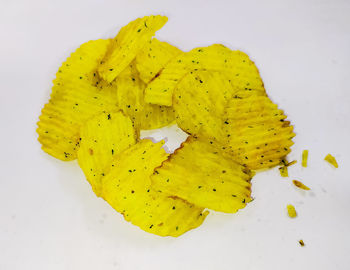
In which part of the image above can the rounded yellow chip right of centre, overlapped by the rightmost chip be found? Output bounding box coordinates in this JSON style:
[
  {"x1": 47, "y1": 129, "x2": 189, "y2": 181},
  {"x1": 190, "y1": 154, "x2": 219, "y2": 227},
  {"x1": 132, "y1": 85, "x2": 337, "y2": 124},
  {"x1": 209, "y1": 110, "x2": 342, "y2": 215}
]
[{"x1": 173, "y1": 70, "x2": 234, "y2": 140}]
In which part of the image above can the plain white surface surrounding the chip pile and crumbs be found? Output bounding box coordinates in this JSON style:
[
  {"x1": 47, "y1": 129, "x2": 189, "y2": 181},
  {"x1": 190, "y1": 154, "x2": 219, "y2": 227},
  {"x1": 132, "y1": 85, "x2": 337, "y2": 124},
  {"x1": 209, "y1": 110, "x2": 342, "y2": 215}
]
[{"x1": 0, "y1": 0, "x2": 350, "y2": 270}]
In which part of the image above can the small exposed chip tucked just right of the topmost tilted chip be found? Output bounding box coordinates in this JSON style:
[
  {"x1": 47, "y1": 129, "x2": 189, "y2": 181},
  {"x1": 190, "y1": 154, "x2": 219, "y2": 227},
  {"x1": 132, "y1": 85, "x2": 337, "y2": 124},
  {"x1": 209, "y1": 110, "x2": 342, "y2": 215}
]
[{"x1": 136, "y1": 38, "x2": 182, "y2": 84}]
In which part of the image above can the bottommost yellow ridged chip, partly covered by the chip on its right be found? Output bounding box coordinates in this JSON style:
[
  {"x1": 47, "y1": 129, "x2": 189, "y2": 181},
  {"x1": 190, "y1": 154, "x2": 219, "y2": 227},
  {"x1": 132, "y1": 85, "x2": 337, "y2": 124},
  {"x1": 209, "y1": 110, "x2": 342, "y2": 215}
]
[{"x1": 102, "y1": 140, "x2": 208, "y2": 236}]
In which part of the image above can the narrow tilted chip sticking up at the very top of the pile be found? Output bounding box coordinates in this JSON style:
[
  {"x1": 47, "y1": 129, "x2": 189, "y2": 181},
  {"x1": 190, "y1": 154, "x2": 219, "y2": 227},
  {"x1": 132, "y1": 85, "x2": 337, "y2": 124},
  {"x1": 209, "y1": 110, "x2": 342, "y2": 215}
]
[{"x1": 98, "y1": 15, "x2": 168, "y2": 82}]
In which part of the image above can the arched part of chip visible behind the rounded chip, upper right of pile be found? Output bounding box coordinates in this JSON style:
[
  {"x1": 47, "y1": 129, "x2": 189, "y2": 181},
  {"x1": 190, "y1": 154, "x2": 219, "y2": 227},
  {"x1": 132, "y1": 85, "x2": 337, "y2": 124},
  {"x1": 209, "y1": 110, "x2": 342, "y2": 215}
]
[{"x1": 145, "y1": 44, "x2": 265, "y2": 106}]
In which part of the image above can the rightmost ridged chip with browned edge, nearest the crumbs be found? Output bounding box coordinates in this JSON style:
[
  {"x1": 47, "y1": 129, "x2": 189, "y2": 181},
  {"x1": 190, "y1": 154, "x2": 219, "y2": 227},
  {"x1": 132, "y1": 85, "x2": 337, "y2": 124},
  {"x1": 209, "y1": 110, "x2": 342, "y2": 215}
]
[{"x1": 222, "y1": 92, "x2": 295, "y2": 170}]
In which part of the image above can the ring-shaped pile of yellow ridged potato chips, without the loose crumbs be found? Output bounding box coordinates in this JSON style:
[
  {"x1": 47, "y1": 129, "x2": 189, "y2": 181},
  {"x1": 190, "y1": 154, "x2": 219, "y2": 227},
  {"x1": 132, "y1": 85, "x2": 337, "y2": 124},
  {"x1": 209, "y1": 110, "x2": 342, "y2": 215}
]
[{"x1": 37, "y1": 16, "x2": 295, "y2": 236}]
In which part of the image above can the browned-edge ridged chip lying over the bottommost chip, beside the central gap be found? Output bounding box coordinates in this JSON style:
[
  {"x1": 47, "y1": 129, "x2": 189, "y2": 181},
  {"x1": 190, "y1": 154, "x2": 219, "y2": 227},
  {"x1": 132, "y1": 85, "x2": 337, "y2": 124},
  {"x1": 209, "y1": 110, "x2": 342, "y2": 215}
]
[{"x1": 151, "y1": 137, "x2": 251, "y2": 213}]
